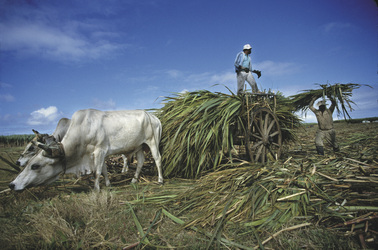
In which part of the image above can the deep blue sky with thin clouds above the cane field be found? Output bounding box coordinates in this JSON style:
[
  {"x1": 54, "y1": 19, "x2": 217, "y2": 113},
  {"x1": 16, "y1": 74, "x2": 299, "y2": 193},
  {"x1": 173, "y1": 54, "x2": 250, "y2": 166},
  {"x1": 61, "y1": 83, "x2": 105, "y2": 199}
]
[{"x1": 0, "y1": 0, "x2": 378, "y2": 135}]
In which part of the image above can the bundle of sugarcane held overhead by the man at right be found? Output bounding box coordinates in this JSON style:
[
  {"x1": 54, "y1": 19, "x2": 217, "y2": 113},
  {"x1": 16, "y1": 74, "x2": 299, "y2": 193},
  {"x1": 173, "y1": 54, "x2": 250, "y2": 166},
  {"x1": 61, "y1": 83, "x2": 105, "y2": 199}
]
[{"x1": 290, "y1": 83, "x2": 371, "y2": 119}]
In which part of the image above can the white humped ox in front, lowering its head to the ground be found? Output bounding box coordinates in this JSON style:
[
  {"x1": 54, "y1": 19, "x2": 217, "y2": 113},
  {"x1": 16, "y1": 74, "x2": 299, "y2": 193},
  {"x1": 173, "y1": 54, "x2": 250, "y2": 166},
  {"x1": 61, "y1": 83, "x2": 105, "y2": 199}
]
[{"x1": 9, "y1": 109, "x2": 163, "y2": 191}]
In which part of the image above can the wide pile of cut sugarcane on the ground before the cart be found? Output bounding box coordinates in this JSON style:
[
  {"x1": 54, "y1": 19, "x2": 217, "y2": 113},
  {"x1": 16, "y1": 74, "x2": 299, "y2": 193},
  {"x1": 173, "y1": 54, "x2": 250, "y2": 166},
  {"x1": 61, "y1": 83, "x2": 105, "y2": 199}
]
[{"x1": 178, "y1": 157, "x2": 378, "y2": 236}]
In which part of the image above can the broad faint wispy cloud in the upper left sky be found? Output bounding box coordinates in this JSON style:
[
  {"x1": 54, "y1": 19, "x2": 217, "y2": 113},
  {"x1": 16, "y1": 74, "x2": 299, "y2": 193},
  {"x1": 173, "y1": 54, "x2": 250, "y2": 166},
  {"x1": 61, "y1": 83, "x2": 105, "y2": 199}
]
[{"x1": 0, "y1": 20, "x2": 127, "y2": 62}]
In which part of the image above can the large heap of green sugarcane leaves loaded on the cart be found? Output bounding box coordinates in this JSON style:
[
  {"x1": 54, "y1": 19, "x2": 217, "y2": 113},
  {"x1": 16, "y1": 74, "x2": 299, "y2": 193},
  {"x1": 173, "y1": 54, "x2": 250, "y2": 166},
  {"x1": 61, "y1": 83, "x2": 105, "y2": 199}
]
[{"x1": 158, "y1": 90, "x2": 300, "y2": 178}]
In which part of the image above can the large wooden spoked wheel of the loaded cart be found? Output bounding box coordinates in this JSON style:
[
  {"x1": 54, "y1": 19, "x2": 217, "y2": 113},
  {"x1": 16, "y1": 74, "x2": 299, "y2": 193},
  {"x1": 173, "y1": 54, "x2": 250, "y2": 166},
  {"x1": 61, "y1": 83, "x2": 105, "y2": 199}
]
[{"x1": 245, "y1": 108, "x2": 282, "y2": 163}]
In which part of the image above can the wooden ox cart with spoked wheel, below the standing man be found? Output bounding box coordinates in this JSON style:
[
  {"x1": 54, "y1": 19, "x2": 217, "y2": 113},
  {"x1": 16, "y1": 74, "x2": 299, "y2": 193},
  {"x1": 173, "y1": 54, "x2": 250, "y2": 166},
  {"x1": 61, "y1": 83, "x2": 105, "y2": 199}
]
[{"x1": 234, "y1": 92, "x2": 282, "y2": 163}]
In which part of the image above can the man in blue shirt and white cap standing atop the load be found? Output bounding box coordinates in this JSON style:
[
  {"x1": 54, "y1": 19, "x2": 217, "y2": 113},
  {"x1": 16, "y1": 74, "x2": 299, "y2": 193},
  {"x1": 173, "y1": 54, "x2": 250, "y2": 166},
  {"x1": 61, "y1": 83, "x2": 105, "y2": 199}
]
[{"x1": 234, "y1": 44, "x2": 261, "y2": 95}]
